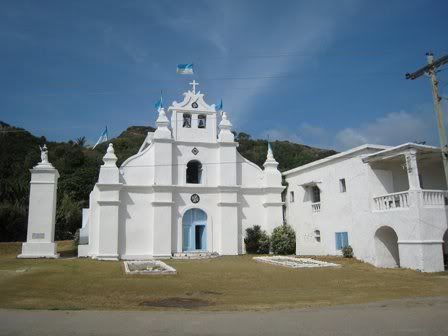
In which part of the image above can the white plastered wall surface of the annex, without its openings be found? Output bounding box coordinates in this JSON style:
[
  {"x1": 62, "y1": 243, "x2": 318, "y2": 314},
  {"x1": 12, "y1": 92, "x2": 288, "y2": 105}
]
[{"x1": 286, "y1": 146, "x2": 448, "y2": 272}]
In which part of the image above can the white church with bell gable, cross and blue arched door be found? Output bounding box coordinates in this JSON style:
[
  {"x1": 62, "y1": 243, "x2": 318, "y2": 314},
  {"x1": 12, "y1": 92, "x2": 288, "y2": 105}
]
[{"x1": 78, "y1": 81, "x2": 284, "y2": 260}]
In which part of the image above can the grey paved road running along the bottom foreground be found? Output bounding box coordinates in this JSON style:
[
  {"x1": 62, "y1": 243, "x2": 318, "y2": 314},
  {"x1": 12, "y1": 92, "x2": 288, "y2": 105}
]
[{"x1": 0, "y1": 298, "x2": 448, "y2": 336}]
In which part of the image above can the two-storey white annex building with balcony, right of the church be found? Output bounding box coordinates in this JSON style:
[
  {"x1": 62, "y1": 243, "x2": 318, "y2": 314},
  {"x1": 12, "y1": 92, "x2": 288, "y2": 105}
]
[{"x1": 283, "y1": 143, "x2": 448, "y2": 272}]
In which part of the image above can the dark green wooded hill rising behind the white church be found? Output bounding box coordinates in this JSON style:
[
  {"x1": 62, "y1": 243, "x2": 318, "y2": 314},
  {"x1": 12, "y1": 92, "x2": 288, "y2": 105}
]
[{"x1": 0, "y1": 121, "x2": 336, "y2": 241}]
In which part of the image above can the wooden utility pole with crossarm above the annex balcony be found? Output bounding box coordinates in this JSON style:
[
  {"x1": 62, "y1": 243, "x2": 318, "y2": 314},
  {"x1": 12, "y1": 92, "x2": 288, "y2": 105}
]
[{"x1": 406, "y1": 53, "x2": 448, "y2": 185}]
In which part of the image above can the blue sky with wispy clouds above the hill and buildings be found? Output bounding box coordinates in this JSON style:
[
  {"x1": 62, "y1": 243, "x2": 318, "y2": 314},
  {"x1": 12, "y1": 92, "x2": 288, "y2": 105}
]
[{"x1": 0, "y1": 0, "x2": 448, "y2": 150}]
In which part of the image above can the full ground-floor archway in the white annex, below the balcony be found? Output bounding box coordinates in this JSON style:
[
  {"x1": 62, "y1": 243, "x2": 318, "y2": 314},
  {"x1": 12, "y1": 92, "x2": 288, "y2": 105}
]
[{"x1": 375, "y1": 226, "x2": 400, "y2": 268}]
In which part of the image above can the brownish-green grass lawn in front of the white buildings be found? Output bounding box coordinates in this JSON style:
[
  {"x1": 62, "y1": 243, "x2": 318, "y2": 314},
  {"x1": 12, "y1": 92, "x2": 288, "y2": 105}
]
[{"x1": 0, "y1": 241, "x2": 448, "y2": 310}]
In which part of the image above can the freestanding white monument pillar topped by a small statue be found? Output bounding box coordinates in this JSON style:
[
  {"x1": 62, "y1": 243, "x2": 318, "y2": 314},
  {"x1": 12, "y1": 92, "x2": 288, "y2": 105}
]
[{"x1": 17, "y1": 145, "x2": 59, "y2": 258}]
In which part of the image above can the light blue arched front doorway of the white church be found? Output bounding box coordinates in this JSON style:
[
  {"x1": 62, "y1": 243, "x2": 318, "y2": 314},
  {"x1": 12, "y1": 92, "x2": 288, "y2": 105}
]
[{"x1": 182, "y1": 209, "x2": 207, "y2": 251}]
